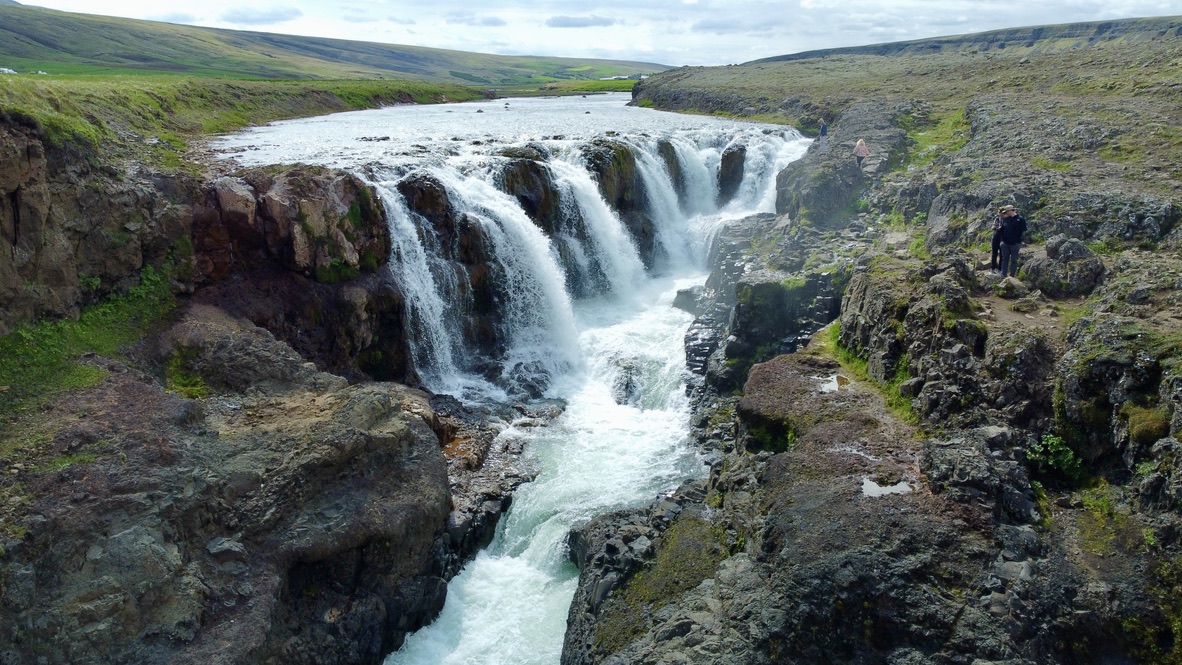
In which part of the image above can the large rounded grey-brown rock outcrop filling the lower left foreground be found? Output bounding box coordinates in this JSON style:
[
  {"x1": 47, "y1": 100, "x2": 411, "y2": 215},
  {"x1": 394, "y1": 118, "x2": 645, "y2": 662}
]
[{"x1": 0, "y1": 307, "x2": 450, "y2": 663}]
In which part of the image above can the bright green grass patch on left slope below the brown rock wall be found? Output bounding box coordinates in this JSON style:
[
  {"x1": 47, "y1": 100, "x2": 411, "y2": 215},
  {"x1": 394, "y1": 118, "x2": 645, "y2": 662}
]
[{"x1": 0, "y1": 267, "x2": 175, "y2": 429}]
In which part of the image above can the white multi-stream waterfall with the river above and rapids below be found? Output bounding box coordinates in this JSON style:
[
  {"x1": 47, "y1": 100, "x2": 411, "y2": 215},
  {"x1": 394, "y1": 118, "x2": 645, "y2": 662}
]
[{"x1": 210, "y1": 96, "x2": 808, "y2": 665}]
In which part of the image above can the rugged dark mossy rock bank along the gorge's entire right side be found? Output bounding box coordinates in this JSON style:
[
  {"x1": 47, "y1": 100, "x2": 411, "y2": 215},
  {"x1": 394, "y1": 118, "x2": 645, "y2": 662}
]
[{"x1": 563, "y1": 20, "x2": 1182, "y2": 665}]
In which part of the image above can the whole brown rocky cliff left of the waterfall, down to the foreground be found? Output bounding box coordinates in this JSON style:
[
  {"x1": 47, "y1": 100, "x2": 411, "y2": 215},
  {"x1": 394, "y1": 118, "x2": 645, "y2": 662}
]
[{"x1": 0, "y1": 116, "x2": 541, "y2": 664}]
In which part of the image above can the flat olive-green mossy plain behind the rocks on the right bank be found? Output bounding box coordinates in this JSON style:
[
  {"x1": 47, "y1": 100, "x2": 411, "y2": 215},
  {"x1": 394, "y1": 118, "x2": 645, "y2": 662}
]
[{"x1": 637, "y1": 19, "x2": 1182, "y2": 198}]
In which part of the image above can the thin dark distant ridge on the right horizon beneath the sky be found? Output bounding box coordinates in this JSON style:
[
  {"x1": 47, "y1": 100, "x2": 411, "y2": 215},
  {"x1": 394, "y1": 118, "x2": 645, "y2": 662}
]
[{"x1": 749, "y1": 17, "x2": 1182, "y2": 64}]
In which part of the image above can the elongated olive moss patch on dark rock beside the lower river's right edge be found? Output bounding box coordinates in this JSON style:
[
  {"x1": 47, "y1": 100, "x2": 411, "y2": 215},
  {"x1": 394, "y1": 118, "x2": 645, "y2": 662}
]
[{"x1": 595, "y1": 515, "x2": 727, "y2": 653}]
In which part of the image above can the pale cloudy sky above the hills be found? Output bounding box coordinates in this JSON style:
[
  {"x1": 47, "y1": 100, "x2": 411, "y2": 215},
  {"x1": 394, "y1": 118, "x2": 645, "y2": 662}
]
[{"x1": 21, "y1": 0, "x2": 1182, "y2": 65}]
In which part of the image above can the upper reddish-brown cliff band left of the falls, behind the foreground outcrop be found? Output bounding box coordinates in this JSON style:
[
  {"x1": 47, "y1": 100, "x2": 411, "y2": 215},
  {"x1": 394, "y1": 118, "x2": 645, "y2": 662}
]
[{"x1": 0, "y1": 117, "x2": 406, "y2": 383}]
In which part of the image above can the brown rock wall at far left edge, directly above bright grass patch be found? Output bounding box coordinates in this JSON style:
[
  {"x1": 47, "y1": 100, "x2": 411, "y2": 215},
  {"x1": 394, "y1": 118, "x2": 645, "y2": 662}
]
[{"x1": 0, "y1": 122, "x2": 191, "y2": 334}]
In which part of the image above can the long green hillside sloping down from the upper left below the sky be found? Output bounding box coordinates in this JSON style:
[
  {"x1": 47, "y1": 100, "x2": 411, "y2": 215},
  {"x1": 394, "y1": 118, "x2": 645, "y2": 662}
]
[{"x1": 0, "y1": 0, "x2": 669, "y2": 86}]
